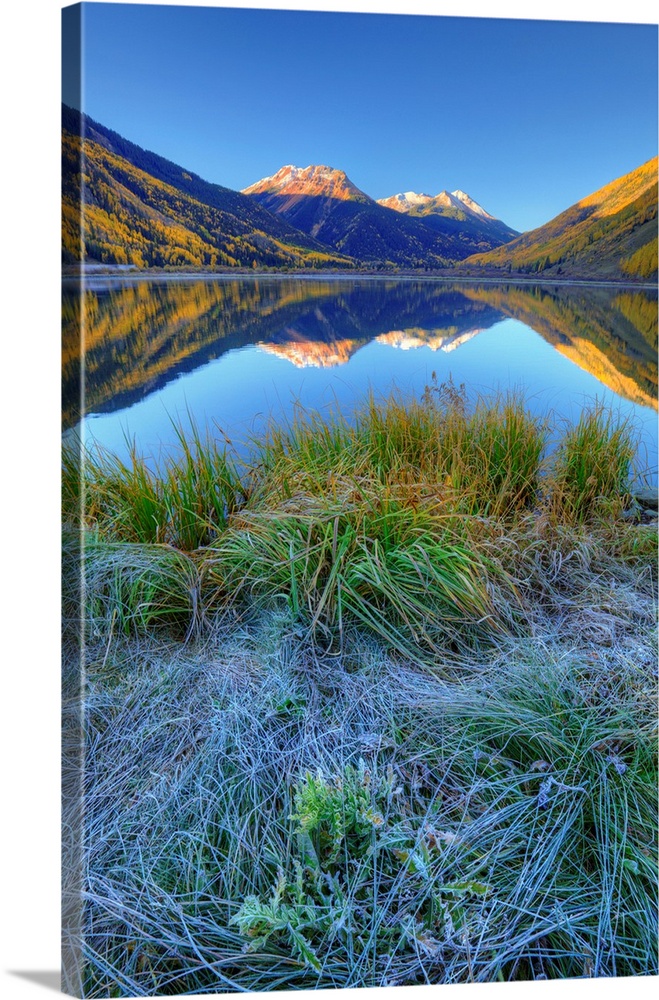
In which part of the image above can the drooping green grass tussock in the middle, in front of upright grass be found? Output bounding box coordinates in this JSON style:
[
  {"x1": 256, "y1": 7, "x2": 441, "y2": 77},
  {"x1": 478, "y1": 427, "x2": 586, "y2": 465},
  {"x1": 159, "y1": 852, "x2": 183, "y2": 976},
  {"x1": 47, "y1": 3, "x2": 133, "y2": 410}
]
[{"x1": 207, "y1": 496, "x2": 513, "y2": 658}]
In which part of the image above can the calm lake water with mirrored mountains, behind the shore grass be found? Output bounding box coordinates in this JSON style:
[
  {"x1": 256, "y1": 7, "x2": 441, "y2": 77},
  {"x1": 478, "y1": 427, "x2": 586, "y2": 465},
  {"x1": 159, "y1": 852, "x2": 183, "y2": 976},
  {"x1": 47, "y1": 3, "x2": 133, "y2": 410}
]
[{"x1": 63, "y1": 277, "x2": 657, "y2": 474}]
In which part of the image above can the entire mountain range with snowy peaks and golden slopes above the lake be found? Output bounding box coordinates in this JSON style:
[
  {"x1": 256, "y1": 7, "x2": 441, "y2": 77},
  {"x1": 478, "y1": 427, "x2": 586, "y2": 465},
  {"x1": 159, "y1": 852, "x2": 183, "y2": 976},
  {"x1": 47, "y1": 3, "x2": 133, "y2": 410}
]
[{"x1": 62, "y1": 106, "x2": 657, "y2": 281}]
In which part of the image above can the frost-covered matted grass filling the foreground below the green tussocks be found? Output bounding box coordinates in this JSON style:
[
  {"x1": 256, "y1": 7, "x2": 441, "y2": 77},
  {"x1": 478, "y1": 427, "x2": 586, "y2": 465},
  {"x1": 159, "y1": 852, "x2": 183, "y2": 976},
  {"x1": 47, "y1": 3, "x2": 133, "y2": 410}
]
[{"x1": 64, "y1": 574, "x2": 657, "y2": 997}]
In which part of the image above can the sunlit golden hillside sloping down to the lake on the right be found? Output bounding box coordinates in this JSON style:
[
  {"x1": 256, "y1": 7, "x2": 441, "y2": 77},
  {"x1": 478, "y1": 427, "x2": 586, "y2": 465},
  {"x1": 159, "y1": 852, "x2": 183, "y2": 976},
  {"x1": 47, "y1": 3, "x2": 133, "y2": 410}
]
[{"x1": 466, "y1": 157, "x2": 657, "y2": 281}]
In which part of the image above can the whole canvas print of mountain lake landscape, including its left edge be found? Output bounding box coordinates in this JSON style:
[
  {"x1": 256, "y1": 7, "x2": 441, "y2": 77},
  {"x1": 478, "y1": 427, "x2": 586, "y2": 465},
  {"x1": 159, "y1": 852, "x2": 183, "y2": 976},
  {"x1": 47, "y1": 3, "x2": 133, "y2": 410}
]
[{"x1": 62, "y1": 3, "x2": 657, "y2": 998}]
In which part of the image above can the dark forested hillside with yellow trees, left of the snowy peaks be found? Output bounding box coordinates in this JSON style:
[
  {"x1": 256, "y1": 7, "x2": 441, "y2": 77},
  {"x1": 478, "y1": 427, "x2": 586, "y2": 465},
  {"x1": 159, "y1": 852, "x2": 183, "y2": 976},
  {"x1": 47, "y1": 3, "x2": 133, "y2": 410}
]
[{"x1": 62, "y1": 108, "x2": 353, "y2": 269}]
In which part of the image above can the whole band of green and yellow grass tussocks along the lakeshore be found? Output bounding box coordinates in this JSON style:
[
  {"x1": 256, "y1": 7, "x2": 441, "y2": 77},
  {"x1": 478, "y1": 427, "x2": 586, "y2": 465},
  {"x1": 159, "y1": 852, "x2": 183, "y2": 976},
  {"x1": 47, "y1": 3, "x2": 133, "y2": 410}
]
[{"x1": 63, "y1": 382, "x2": 652, "y2": 659}]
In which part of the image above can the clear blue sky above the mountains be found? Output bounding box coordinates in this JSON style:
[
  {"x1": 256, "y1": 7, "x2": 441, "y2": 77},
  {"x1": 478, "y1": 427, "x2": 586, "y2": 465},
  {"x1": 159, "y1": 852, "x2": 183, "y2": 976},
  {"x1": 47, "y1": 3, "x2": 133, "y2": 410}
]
[{"x1": 63, "y1": 4, "x2": 657, "y2": 230}]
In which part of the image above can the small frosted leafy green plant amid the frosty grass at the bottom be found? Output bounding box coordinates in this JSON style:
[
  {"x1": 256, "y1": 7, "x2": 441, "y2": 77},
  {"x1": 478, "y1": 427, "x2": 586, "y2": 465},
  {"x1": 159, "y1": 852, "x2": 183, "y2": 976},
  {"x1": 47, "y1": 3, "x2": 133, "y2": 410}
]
[{"x1": 232, "y1": 760, "x2": 490, "y2": 973}]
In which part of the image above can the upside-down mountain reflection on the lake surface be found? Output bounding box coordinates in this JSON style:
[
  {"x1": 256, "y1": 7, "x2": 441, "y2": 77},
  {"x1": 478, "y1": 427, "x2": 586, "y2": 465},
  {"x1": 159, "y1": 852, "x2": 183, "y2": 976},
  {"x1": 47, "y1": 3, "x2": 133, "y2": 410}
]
[{"x1": 63, "y1": 279, "x2": 657, "y2": 426}]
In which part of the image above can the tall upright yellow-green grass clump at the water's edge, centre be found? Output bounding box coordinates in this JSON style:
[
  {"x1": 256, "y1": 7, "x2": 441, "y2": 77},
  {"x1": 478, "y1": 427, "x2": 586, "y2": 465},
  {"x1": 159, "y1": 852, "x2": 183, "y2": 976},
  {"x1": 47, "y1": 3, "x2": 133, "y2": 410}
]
[{"x1": 252, "y1": 382, "x2": 546, "y2": 516}]
